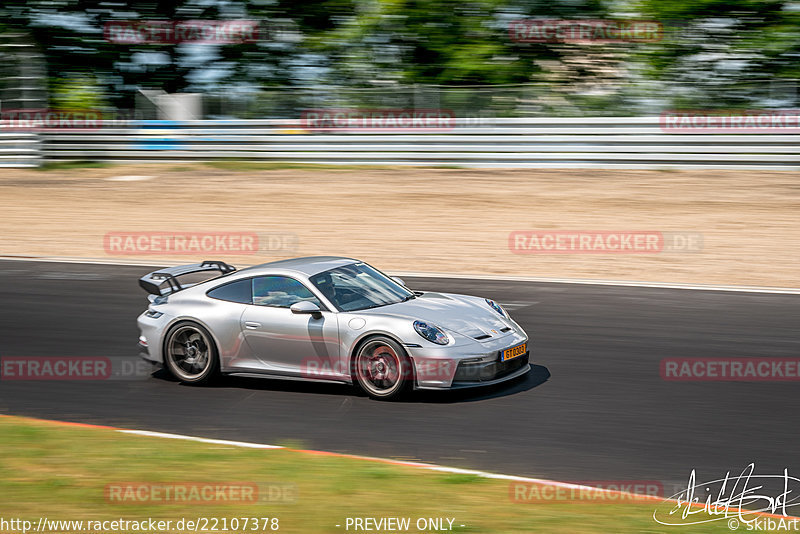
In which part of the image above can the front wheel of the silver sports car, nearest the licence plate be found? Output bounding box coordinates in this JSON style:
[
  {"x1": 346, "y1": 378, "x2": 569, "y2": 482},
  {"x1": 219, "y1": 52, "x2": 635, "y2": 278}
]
[{"x1": 354, "y1": 336, "x2": 413, "y2": 400}]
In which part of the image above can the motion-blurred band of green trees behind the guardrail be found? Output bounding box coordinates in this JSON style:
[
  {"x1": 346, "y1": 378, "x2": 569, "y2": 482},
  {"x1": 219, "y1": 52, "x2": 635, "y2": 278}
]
[{"x1": 0, "y1": 0, "x2": 800, "y2": 113}]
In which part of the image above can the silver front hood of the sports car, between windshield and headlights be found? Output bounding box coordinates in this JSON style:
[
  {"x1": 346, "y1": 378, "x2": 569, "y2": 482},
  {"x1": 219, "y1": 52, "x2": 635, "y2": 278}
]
[{"x1": 361, "y1": 292, "x2": 512, "y2": 339}]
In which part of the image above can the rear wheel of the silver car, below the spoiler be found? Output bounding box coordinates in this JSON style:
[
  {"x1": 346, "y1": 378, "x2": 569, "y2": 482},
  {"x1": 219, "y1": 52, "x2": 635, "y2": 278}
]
[{"x1": 164, "y1": 322, "x2": 219, "y2": 385}]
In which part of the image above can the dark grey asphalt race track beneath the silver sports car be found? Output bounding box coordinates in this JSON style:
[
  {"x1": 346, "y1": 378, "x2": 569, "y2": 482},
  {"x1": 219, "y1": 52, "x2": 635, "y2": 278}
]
[{"x1": 0, "y1": 261, "x2": 800, "y2": 498}]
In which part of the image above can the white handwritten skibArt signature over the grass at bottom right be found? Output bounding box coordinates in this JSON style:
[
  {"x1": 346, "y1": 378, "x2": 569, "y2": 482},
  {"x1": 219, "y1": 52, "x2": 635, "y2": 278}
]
[{"x1": 653, "y1": 463, "x2": 800, "y2": 531}]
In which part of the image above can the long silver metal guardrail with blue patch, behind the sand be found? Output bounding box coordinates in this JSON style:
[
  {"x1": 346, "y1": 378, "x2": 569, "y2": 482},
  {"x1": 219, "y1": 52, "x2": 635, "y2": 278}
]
[{"x1": 20, "y1": 117, "x2": 800, "y2": 170}]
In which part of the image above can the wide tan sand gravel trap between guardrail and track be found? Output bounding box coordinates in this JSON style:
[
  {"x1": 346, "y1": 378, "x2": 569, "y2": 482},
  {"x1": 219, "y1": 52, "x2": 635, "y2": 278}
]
[{"x1": 0, "y1": 164, "x2": 800, "y2": 287}]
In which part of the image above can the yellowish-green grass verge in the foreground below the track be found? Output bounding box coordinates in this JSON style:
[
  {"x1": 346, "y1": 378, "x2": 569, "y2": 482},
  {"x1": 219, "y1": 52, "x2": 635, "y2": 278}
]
[{"x1": 0, "y1": 417, "x2": 730, "y2": 533}]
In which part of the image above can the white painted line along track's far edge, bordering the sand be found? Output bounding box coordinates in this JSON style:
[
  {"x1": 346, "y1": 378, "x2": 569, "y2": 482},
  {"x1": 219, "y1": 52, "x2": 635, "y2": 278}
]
[{"x1": 0, "y1": 256, "x2": 800, "y2": 295}]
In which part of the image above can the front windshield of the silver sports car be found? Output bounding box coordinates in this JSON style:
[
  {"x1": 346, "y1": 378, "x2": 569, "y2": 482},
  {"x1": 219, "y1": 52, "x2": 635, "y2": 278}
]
[{"x1": 309, "y1": 263, "x2": 414, "y2": 311}]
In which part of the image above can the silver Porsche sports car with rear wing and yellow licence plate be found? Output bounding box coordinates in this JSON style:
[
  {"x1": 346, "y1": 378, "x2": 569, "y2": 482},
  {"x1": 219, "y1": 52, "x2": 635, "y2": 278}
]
[{"x1": 138, "y1": 256, "x2": 530, "y2": 399}]
